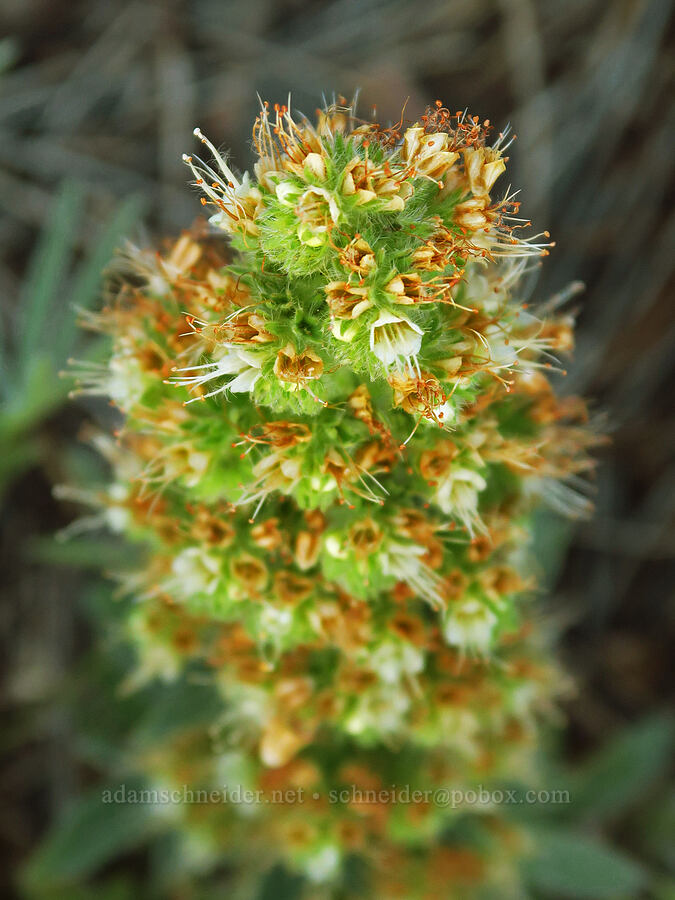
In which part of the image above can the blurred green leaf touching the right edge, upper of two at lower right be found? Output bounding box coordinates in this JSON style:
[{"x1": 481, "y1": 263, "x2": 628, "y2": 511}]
[{"x1": 571, "y1": 715, "x2": 675, "y2": 820}]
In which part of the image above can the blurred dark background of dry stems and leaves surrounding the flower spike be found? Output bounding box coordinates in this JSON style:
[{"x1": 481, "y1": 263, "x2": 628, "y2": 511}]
[{"x1": 0, "y1": 0, "x2": 675, "y2": 900}]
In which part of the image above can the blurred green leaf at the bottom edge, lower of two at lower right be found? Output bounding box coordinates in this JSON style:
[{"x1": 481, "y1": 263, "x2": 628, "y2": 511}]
[{"x1": 523, "y1": 830, "x2": 647, "y2": 900}]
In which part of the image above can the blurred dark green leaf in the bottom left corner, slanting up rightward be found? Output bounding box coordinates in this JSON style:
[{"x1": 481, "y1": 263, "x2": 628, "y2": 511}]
[{"x1": 22, "y1": 778, "x2": 160, "y2": 891}]
